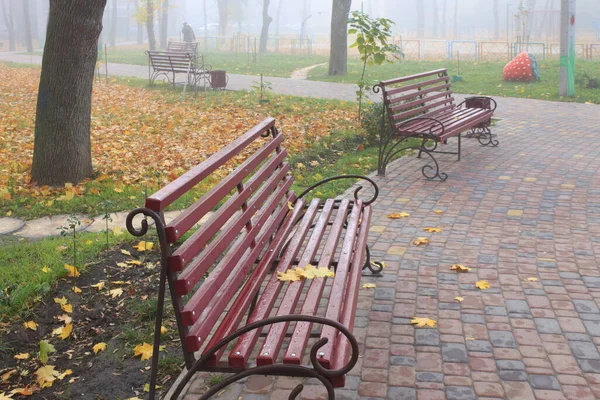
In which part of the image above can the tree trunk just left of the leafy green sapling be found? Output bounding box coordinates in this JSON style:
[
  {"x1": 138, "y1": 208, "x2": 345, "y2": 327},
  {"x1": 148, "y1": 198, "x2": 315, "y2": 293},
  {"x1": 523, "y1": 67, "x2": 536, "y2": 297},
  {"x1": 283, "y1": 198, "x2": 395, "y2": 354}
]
[{"x1": 328, "y1": 0, "x2": 352, "y2": 76}]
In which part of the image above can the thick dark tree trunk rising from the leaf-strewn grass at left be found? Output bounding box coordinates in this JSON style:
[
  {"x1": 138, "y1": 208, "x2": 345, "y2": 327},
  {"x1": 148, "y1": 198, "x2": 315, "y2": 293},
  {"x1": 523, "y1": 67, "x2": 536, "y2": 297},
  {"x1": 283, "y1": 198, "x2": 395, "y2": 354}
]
[{"x1": 31, "y1": 0, "x2": 107, "y2": 185}]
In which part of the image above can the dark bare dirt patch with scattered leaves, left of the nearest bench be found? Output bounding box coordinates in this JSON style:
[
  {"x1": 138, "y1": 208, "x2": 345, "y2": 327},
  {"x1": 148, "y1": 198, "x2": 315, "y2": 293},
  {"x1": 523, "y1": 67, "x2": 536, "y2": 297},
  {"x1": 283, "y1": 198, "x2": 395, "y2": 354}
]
[{"x1": 0, "y1": 245, "x2": 183, "y2": 400}]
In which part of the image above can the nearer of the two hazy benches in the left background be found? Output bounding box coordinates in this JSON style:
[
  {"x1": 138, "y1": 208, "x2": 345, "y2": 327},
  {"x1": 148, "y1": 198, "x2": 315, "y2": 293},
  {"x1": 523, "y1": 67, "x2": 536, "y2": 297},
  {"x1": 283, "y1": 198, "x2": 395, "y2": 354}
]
[{"x1": 146, "y1": 50, "x2": 210, "y2": 90}]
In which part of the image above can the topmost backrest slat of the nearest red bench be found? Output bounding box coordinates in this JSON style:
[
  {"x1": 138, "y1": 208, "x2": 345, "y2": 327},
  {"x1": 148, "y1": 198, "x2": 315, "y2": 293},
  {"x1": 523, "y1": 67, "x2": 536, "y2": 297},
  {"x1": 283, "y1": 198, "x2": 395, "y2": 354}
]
[{"x1": 146, "y1": 117, "x2": 275, "y2": 212}]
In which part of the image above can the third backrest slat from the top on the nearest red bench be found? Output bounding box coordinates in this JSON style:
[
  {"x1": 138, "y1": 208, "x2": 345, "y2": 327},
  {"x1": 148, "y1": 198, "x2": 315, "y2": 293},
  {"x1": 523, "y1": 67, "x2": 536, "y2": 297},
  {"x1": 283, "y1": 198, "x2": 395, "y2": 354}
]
[{"x1": 169, "y1": 152, "x2": 289, "y2": 271}]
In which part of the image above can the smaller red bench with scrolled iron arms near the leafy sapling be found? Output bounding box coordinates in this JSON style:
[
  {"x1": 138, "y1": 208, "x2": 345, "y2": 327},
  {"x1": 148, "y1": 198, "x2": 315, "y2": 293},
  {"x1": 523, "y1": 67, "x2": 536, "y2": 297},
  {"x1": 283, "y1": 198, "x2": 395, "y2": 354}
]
[{"x1": 373, "y1": 69, "x2": 499, "y2": 181}]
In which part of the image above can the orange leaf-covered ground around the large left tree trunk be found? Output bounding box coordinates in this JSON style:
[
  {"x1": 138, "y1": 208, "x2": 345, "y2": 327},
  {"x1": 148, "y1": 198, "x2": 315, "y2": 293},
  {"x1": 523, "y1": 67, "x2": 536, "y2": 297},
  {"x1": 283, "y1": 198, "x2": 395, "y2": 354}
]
[{"x1": 0, "y1": 64, "x2": 356, "y2": 215}]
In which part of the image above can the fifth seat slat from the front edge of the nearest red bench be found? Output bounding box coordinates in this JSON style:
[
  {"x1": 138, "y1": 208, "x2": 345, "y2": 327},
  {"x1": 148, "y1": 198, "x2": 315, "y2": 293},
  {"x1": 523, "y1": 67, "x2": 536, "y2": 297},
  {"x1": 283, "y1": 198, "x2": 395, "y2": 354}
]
[{"x1": 229, "y1": 199, "x2": 319, "y2": 368}]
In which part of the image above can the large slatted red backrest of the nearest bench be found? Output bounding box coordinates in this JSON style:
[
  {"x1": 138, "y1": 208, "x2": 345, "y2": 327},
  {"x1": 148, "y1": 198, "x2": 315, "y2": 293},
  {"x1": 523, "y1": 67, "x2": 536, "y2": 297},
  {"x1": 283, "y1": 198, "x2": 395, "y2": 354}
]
[{"x1": 146, "y1": 118, "x2": 304, "y2": 365}]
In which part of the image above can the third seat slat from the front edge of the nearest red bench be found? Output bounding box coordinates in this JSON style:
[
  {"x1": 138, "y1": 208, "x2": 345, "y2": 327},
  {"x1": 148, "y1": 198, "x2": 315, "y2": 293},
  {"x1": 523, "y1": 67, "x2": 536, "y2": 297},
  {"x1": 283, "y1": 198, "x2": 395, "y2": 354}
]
[{"x1": 283, "y1": 199, "x2": 350, "y2": 364}]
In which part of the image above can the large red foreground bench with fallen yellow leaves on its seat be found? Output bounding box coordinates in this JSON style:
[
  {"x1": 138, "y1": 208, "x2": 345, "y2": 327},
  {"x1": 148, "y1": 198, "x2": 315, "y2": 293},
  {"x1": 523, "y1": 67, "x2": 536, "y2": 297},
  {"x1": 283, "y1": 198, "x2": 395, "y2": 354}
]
[{"x1": 126, "y1": 118, "x2": 382, "y2": 398}]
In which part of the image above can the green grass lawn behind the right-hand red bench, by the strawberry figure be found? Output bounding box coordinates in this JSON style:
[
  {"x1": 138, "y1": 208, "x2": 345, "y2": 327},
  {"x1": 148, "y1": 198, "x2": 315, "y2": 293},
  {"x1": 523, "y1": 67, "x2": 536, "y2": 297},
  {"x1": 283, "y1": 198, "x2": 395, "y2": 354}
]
[{"x1": 309, "y1": 58, "x2": 600, "y2": 103}]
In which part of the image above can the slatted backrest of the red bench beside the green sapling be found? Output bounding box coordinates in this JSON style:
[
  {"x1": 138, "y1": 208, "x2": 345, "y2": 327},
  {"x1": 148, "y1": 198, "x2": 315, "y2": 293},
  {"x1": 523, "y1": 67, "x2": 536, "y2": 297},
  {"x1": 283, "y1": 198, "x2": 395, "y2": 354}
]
[{"x1": 379, "y1": 69, "x2": 455, "y2": 126}]
